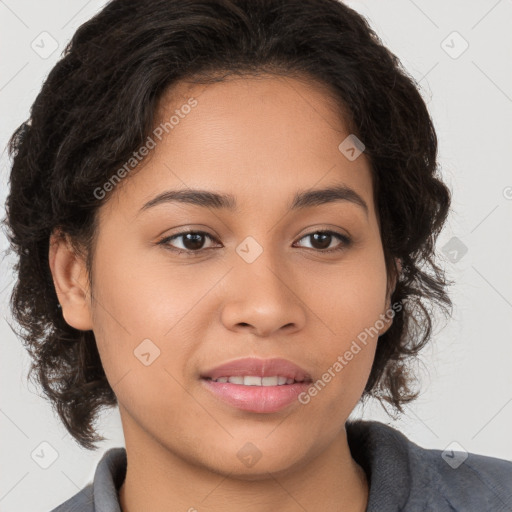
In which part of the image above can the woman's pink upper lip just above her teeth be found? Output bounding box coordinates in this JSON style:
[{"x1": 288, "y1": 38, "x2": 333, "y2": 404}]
[{"x1": 201, "y1": 357, "x2": 311, "y2": 382}]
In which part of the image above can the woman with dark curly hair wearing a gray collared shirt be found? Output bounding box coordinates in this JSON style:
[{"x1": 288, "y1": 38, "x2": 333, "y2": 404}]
[{"x1": 7, "y1": 0, "x2": 512, "y2": 512}]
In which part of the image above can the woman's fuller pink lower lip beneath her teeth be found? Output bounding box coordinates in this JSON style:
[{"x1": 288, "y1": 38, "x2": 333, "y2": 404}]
[{"x1": 201, "y1": 379, "x2": 310, "y2": 413}]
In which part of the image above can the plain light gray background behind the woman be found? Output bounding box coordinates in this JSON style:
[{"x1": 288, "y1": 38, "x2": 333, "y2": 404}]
[{"x1": 0, "y1": 0, "x2": 512, "y2": 512}]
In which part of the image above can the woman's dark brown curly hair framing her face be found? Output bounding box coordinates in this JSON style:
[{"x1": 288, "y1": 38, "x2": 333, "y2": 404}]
[{"x1": 5, "y1": 0, "x2": 452, "y2": 449}]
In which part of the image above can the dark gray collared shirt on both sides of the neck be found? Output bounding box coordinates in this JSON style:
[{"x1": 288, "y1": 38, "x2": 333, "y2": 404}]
[{"x1": 51, "y1": 421, "x2": 512, "y2": 512}]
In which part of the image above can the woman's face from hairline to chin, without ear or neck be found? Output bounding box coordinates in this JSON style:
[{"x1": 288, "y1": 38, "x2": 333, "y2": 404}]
[{"x1": 83, "y1": 76, "x2": 389, "y2": 478}]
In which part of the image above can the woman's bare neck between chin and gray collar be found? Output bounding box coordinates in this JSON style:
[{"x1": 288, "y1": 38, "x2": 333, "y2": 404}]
[{"x1": 119, "y1": 418, "x2": 368, "y2": 512}]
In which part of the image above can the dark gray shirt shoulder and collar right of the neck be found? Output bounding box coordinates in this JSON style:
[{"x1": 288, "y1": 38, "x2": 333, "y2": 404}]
[{"x1": 347, "y1": 421, "x2": 512, "y2": 512}]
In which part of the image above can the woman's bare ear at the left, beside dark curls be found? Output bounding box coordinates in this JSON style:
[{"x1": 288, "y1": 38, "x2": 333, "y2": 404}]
[{"x1": 48, "y1": 231, "x2": 92, "y2": 331}]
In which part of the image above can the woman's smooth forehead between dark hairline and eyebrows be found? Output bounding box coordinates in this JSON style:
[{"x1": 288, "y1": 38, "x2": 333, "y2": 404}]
[{"x1": 102, "y1": 75, "x2": 373, "y2": 220}]
